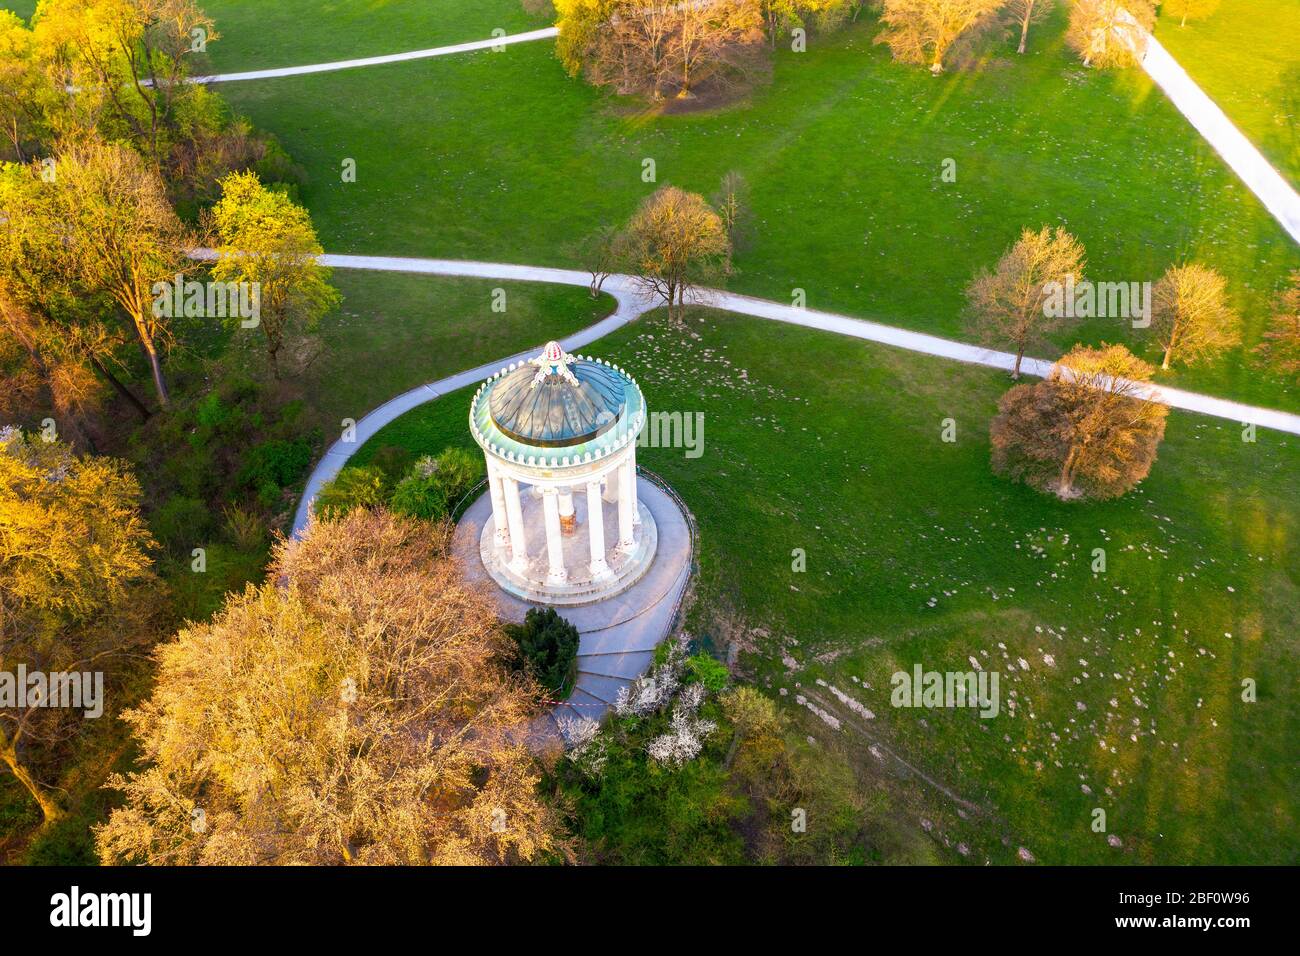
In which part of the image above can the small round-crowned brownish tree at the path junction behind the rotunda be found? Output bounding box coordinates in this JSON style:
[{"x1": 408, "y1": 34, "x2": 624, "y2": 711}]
[{"x1": 625, "y1": 186, "x2": 731, "y2": 320}]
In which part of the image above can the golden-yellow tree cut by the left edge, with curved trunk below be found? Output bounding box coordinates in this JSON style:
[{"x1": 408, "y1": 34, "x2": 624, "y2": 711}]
[{"x1": 0, "y1": 428, "x2": 157, "y2": 823}]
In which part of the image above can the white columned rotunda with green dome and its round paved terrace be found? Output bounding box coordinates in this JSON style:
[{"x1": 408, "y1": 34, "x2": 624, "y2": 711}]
[{"x1": 452, "y1": 342, "x2": 693, "y2": 735}]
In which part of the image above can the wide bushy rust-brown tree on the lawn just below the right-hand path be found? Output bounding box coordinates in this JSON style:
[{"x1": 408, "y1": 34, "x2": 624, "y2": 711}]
[{"x1": 989, "y1": 345, "x2": 1169, "y2": 501}]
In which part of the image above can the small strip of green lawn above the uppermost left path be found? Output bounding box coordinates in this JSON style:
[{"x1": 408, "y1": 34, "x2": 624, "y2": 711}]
[{"x1": 202, "y1": 0, "x2": 549, "y2": 73}]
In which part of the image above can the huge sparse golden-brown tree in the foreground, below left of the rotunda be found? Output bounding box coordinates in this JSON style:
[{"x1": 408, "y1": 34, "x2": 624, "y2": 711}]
[{"x1": 95, "y1": 512, "x2": 569, "y2": 865}]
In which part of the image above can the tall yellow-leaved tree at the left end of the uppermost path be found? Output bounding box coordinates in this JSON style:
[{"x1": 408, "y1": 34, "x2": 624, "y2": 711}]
[{"x1": 33, "y1": 0, "x2": 218, "y2": 172}]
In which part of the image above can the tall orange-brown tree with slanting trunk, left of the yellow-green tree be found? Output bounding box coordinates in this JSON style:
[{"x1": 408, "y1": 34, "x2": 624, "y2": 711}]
[{"x1": 56, "y1": 142, "x2": 195, "y2": 407}]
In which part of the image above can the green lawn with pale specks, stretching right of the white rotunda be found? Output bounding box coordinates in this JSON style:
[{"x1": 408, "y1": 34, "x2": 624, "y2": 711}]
[{"x1": 361, "y1": 313, "x2": 1300, "y2": 864}]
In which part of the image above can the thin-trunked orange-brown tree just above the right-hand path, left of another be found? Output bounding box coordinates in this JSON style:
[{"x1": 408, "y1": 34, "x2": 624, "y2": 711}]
[{"x1": 966, "y1": 226, "x2": 1084, "y2": 378}]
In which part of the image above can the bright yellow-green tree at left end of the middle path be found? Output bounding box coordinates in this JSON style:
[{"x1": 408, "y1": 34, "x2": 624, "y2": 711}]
[{"x1": 212, "y1": 173, "x2": 341, "y2": 378}]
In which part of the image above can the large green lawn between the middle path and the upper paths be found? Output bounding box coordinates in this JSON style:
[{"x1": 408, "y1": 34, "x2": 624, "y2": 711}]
[{"x1": 224, "y1": 10, "x2": 1300, "y2": 408}]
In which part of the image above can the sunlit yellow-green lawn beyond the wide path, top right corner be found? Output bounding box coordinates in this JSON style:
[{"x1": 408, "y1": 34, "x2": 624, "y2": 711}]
[{"x1": 1156, "y1": 0, "x2": 1300, "y2": 186}]
